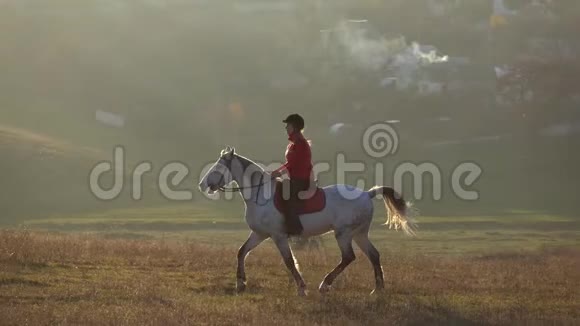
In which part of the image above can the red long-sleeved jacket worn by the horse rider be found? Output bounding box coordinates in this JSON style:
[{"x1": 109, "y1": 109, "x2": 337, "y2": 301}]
[{"x1": 275, "y1": 132, "x2": 312, "y2": 180}]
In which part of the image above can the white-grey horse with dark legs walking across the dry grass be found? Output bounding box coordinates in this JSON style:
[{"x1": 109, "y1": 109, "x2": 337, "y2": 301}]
[{"x1": 199, "y1": 146, "x2": 416, "y2": 295}]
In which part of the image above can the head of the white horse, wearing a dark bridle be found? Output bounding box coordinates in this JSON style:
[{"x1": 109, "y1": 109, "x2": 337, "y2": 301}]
[{"x1": 199, "y1": 146, "x2": 236, "y2": 194}]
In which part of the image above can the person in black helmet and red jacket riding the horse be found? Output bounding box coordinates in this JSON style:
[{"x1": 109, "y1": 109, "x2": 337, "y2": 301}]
[{"x1": 272, "y1": 113, "x2": 312, "y2": 235}]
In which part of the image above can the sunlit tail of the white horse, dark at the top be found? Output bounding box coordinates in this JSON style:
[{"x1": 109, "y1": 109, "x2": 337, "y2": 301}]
[{"x1": 367, "y1": 186, "x2": 417, "y2": 236}]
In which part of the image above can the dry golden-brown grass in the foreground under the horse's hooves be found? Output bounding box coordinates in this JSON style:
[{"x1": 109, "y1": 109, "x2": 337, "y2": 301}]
[{"x1": 0, "y1": 230, "x2": 580, "y2": 325}]
